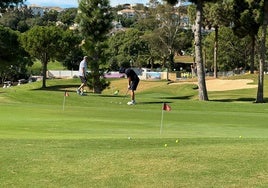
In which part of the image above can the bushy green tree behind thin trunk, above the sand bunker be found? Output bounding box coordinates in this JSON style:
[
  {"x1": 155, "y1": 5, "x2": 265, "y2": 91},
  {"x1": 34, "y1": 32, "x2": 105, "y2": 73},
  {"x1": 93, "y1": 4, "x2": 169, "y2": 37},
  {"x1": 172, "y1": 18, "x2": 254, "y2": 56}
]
[{"x1": 203, "y1": 27, "x2": 250, "y2": 73}]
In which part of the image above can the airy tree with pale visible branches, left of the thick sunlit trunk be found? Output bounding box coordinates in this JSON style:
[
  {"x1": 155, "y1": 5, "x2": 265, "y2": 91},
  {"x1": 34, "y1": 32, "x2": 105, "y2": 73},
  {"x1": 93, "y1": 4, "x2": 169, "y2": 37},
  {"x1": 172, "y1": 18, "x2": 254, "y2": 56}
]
[{"x1": 135, "y1": 0, "x2": 192, "y2": 70}]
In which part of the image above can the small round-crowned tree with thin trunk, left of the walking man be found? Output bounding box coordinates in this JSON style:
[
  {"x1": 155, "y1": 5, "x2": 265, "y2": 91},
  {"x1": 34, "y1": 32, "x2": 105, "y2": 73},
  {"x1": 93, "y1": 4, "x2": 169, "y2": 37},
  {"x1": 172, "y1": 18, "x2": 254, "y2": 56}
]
[{"x1": 20, "y1": 26, "x2": 77, "y2": 88}]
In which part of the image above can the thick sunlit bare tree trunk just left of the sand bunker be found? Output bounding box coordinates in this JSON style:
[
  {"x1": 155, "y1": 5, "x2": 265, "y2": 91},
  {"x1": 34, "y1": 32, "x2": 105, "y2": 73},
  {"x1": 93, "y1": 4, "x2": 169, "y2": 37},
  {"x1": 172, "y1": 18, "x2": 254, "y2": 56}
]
[{"x1": 194, "y1": 0, "x2": 208, "y2": 101}]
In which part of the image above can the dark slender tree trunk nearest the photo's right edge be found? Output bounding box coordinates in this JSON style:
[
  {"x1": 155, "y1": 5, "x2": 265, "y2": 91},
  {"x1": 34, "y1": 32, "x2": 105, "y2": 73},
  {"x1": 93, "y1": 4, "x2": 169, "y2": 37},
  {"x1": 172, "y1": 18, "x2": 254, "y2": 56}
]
[{"x1": 256, "y1": 1, "x2": 268, "y2": 103}]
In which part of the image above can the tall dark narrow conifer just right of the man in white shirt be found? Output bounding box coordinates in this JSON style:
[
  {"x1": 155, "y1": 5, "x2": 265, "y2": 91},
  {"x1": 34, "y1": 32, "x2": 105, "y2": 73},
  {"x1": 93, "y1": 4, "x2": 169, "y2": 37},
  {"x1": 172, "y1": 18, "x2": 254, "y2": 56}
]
[{"x1": 77, "y1": 0, "x2": 113, "y2": 93}]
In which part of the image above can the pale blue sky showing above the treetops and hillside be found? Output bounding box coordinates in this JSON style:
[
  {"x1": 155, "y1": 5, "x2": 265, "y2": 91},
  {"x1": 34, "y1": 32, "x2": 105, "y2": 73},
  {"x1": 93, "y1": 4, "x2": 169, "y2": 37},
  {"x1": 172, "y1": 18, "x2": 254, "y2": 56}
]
[{"x1": 26, "y1": 0, "x2": 149, "y2": 8}]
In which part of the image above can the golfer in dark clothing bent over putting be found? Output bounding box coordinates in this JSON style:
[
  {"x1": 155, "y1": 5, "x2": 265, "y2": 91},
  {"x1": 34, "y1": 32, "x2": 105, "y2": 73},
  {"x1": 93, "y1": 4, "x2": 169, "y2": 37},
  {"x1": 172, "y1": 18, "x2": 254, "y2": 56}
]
[{"x1": 125, "y1": 68, "x2": 140, "y2": 105}]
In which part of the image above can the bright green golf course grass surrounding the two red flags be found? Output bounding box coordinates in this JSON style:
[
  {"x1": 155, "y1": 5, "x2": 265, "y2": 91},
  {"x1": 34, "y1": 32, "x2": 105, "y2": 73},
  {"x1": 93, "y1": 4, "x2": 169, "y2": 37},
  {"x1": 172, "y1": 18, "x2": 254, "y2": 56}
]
[{"x1": 0, "y1": 79, "x2": 268, "y2": 188}]
